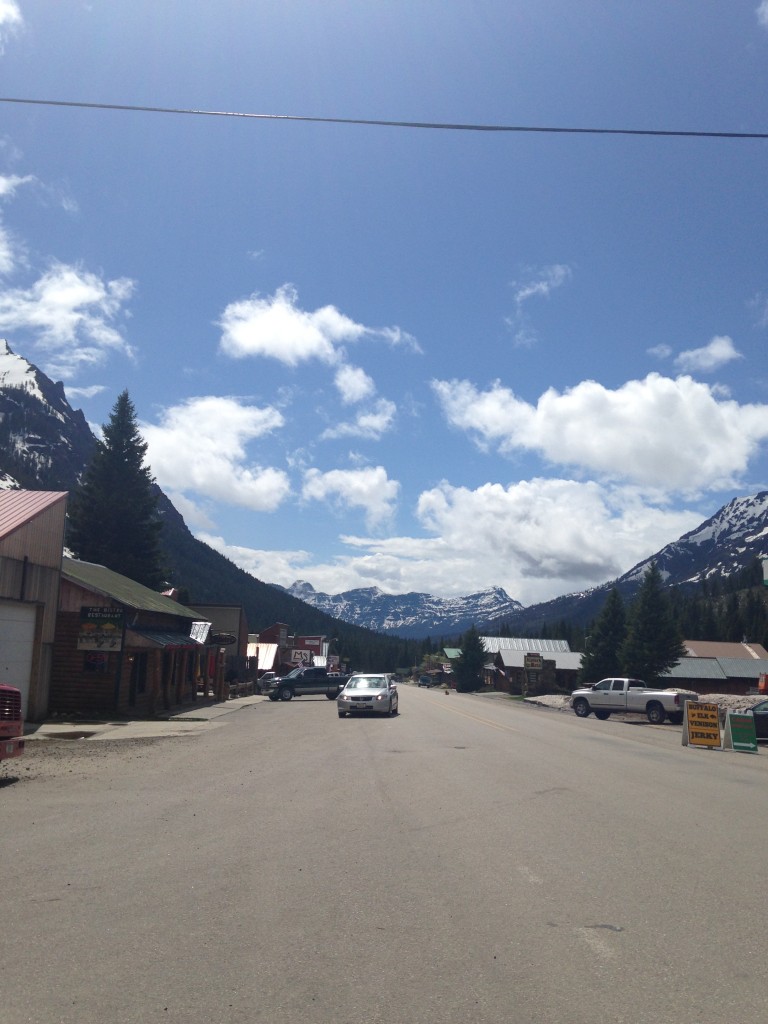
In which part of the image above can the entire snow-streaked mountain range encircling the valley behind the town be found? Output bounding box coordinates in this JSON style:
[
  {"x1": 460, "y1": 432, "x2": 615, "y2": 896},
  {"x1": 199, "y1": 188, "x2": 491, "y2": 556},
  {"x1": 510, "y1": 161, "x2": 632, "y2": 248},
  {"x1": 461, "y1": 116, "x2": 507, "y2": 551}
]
[{"x1": 0, "y1": 340, "x2": 768, "y2": 643}]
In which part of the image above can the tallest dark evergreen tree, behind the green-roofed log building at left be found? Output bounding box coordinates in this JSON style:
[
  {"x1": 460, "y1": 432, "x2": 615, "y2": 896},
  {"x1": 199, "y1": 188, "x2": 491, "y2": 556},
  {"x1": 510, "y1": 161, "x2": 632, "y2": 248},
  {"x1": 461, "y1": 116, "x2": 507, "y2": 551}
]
[{"x1": 68, "y1": 391, "x2": 164, "y2": 589}]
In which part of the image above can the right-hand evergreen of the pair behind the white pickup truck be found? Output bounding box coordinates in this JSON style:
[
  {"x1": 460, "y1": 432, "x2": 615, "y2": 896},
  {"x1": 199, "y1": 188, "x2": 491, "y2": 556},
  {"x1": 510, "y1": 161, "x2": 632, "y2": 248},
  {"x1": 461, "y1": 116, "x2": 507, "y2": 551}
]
[{"x1": 620, "y1": 562, "x2": 685, "y2": 684}]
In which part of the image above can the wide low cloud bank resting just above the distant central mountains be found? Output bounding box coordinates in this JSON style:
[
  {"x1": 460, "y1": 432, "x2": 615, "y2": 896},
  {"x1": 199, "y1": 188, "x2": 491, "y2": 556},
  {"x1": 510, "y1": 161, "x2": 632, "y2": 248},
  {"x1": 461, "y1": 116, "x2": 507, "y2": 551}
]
[{"x1": 202, "y1": 479, "x2": 701, "y2": 604}]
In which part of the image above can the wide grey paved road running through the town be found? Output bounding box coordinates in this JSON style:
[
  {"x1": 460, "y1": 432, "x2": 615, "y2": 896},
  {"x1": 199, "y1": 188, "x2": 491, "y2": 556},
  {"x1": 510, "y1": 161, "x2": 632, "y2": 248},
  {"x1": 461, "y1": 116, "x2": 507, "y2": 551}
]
[{"x1": 0, "y1": 687, "x2": 768, "y2": 1024}]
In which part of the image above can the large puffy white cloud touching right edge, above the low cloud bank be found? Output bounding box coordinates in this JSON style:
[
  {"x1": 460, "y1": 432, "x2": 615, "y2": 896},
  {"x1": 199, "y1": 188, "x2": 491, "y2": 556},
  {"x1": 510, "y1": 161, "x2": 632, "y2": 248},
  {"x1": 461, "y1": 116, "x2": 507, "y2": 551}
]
[{"x1": 432, "y1": 374, "x2": 768, "y2": 494}]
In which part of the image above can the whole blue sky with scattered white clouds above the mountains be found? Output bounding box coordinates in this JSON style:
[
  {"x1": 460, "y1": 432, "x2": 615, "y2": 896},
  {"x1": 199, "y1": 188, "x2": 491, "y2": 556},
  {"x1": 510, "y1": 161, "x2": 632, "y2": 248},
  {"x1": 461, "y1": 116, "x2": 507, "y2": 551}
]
[{"x1": 0, "y1": 0, "x2": 768, "y2": 605}]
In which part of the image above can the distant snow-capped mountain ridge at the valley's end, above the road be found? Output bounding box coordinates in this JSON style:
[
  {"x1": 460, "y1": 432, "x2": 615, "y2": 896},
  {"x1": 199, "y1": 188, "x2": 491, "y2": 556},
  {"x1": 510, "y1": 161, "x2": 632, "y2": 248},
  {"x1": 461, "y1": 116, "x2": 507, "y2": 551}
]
[{"x1": 280, "y1": 580, "x2": 522, "y2": 638}]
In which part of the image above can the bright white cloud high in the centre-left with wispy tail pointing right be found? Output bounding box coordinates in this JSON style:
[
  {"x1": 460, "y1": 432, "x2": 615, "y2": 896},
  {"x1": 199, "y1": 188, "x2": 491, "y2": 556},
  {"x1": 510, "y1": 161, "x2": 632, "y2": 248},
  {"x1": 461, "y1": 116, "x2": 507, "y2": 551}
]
[{"x1": 219, "y1": 285, "x2": 421, "y2": 367}]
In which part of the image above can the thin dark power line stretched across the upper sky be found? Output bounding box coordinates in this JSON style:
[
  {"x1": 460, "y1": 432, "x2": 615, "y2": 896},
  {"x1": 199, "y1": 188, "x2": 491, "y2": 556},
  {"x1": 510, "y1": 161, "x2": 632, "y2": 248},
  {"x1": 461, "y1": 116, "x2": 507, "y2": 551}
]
[{"x1": 0, "y1": 96, "x2": 768, "y2": 139}]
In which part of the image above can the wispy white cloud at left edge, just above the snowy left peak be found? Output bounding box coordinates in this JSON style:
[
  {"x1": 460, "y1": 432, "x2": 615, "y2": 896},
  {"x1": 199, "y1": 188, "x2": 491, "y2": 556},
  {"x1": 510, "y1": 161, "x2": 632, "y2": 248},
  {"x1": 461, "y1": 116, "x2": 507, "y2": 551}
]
[{"x1": 0, "y1": 263, "x2": 134, "y2": 380}]
